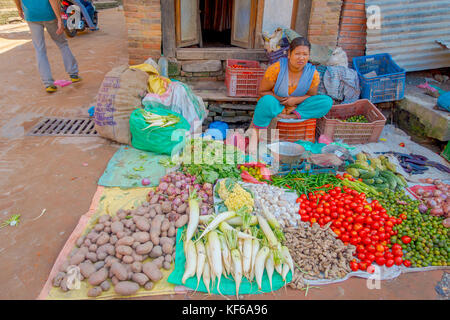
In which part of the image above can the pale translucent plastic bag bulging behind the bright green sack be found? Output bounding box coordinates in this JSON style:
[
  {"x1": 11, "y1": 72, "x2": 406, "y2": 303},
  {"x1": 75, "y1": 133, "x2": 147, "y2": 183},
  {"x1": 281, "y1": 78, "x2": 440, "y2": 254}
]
[{"x1": 142, "y1": 81, "x2": 206, "y2": 133}]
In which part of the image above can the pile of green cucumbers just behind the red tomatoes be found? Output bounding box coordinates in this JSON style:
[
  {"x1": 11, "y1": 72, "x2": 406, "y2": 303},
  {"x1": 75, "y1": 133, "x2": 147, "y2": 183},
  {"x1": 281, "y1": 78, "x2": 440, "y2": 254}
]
[{"x1": 346, "y1": 153, "x2": 408, "y2": 191}]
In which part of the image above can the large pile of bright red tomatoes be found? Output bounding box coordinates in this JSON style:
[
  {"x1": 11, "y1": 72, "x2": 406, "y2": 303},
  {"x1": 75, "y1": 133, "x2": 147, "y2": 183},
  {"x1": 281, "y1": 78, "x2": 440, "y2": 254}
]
[{"x1": 297, "y1": 187, "x2": 410, "y2": 273}]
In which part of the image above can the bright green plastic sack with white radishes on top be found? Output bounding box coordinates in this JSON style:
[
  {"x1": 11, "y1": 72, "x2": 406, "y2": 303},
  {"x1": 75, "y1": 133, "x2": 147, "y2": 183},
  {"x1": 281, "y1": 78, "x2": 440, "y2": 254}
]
[{"x1": 130, "y1": 108, "x2": 191, "y2": 155}]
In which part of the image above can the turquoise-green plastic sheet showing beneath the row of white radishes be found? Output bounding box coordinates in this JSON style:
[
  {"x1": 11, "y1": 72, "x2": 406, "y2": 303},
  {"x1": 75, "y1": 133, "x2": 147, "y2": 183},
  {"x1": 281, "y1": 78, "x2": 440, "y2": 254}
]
[{"x1": 167, "y1": 226, "x2": 292, "y2": 295}]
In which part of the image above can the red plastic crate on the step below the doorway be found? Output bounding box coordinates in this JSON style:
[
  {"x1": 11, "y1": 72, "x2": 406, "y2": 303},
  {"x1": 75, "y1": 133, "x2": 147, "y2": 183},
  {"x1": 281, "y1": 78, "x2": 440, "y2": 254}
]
[{"x1": 225, "y1": 59, "x2": 265, "y2": 97}]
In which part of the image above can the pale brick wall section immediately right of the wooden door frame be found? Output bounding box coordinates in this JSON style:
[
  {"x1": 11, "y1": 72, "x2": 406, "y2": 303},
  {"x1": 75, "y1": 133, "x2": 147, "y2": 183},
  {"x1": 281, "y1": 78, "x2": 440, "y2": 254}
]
[{"x1": 308, "y1": 0, "x2": 342, "y2": 46}]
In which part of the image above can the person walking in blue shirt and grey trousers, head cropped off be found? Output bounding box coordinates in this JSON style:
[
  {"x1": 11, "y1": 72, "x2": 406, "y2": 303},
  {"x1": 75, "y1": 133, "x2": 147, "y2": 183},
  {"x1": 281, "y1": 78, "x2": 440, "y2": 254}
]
[{"x1": 14, "y1": 0, "x2": 81, "y2": 93}]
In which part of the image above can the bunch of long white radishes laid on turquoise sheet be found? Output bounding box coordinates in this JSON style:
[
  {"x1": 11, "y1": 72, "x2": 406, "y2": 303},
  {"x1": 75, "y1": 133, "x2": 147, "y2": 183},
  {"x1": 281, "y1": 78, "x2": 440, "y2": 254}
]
[{"x1": 182, "y1": 185, "x2": 294, "y2": 296}]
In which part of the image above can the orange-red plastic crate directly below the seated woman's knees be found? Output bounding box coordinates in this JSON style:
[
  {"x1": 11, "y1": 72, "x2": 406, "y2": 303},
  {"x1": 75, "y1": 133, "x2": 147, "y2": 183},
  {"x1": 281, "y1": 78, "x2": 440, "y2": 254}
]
[{"x1": 277, "y1": 119, "x2": 316, "y2": 142}]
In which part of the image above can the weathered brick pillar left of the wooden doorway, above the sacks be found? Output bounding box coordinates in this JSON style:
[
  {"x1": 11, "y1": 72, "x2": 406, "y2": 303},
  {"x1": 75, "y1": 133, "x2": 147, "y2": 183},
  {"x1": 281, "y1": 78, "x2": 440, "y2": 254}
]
[{"x1": 123, "y1": 0, "x2": 162, "y2": 65}]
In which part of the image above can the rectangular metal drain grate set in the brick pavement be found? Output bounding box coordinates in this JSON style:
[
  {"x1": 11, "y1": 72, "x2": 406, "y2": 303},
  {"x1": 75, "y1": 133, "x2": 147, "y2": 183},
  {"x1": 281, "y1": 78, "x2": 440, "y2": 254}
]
[{"x1": 27, "y1": 118, "x2": 97, "y2": 137}]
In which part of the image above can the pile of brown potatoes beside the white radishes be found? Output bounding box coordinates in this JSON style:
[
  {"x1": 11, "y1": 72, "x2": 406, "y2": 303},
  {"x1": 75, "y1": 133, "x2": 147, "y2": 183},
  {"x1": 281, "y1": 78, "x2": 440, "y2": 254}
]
[{"x1": 53, "y1": 202, "x2": 188, "y2": 297}]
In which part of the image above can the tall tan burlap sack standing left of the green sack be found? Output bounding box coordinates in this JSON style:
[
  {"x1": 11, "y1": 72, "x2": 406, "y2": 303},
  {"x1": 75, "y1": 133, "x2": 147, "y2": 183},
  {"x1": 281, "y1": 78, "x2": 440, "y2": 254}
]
[{"x1": 94, "y1": 65, "x2": 148, "y2": 144}]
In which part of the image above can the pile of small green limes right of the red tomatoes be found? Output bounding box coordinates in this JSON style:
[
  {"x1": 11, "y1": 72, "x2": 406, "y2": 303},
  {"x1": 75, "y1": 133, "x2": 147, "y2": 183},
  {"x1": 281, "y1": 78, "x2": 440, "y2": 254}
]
[{"x1": 377, "y1": 190, "x2": 450, "y2": 268}]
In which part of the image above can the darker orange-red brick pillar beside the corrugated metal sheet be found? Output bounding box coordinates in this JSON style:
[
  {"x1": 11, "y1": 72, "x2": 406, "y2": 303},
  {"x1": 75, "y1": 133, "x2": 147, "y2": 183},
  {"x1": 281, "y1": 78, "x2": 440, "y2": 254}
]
[{"x1": 338, "y1": 0, "x2": 367, "y2": 63}]
